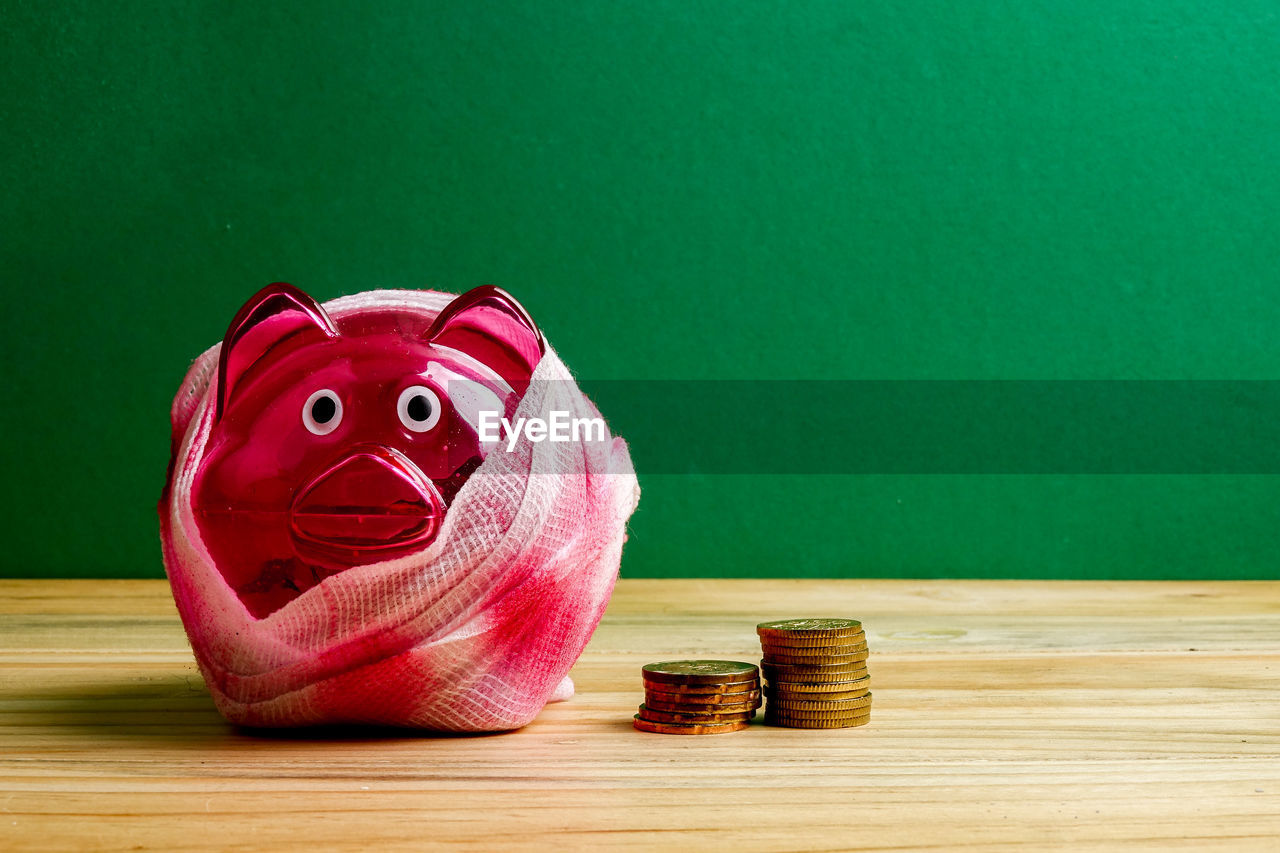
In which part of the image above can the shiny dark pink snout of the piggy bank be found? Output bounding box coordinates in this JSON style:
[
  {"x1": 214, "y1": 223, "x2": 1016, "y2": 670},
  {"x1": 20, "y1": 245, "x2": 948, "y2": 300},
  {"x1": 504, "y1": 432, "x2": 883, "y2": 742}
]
[{"x1": 289, "y1": 444, "x2": 445, "y2": 560}]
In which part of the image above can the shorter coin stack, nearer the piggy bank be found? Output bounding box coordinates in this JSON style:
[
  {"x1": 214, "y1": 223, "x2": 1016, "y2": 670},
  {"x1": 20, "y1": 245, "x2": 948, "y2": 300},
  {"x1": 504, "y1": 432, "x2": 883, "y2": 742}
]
[{"x1": 634, "y1": 661, "x2": 760, "y2": 734}]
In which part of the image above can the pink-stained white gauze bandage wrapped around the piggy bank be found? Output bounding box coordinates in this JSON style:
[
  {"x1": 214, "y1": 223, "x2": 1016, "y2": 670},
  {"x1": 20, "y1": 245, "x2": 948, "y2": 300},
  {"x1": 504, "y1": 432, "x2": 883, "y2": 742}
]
[{"x1": 160, "y1": 291, "x2": 640, "y2": 731}]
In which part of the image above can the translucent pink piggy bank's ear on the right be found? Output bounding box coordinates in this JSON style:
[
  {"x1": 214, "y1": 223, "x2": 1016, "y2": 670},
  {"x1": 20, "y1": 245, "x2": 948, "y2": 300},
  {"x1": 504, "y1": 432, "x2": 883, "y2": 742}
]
[{"x1": 426, "y1": 284, "x2": 547, "y2": 393}]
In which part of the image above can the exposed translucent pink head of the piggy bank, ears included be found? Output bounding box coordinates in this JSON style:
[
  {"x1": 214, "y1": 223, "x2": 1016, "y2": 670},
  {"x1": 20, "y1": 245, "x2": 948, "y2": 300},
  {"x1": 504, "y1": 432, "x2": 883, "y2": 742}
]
[{"x1": 192, "y1": 284, "x2": 545, "y2": 617}]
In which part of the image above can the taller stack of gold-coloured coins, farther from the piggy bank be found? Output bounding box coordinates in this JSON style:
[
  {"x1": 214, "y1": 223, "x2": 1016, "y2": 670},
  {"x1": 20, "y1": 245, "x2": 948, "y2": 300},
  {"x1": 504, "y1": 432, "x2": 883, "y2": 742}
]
[{"x1": 755, "y1": 619, "x2": 872, "y2": 729}]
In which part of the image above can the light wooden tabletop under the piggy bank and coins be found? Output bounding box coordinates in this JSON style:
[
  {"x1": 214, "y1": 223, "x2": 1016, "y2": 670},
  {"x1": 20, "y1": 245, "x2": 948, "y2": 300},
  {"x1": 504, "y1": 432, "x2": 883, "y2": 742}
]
[{"x1": 0, "y1": 580, "x2": 1280, "y2": 850}]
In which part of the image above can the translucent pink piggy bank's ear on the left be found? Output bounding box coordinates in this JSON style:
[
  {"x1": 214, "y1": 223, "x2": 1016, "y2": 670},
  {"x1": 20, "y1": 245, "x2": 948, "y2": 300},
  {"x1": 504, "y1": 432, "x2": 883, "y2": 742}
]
[{"x1": 218, "y1": 282, "x2": 338, "y2": 418}]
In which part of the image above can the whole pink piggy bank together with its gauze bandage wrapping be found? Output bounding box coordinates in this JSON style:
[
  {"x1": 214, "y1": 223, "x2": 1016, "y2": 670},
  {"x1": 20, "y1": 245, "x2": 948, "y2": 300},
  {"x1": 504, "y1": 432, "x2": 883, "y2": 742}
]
[{"x1": 159, "y1": 284, "x2": 639, "y2": 731}]
